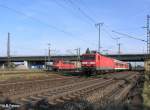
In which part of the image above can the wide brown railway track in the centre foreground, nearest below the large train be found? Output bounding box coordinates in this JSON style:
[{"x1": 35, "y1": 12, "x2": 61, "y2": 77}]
[{"x1": 12, "y1": 79, "x2": 112, "y2": 104}]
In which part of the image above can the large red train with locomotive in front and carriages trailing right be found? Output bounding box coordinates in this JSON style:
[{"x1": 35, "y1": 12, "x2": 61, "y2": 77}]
[{"x1": 81, "y1": 52, "x2": 129, "y2": 74}]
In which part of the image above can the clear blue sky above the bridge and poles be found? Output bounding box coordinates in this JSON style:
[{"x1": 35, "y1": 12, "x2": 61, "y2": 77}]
[{"x1": 0, "y1": 0, "x2": 150, "y2": 56}]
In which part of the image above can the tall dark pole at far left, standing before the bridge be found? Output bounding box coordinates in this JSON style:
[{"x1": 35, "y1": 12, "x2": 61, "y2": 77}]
[{"x1": 7, "y1": 32, "x2": 11, "y2": 69}]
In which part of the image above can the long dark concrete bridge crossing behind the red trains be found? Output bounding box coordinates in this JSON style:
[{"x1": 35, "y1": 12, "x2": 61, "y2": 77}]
[{"x1": 0, "y1": 54, "x2": 149, "y2": 68}]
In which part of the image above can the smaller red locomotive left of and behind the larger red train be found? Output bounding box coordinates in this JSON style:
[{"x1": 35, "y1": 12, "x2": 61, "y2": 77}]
[{"x1": 52, "y1": 60, "x2": 76, "y2": 71}]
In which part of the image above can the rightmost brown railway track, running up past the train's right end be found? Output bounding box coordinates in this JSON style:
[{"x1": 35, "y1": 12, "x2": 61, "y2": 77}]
[{"x1": 97, "y1": 75, "x2": 139, "y2": 106}]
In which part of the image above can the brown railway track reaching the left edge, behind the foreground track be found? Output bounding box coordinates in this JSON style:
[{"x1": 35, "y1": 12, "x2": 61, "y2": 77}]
[{"x1": 0, "y1": 77, "x2": 86, "y2": 97}]
